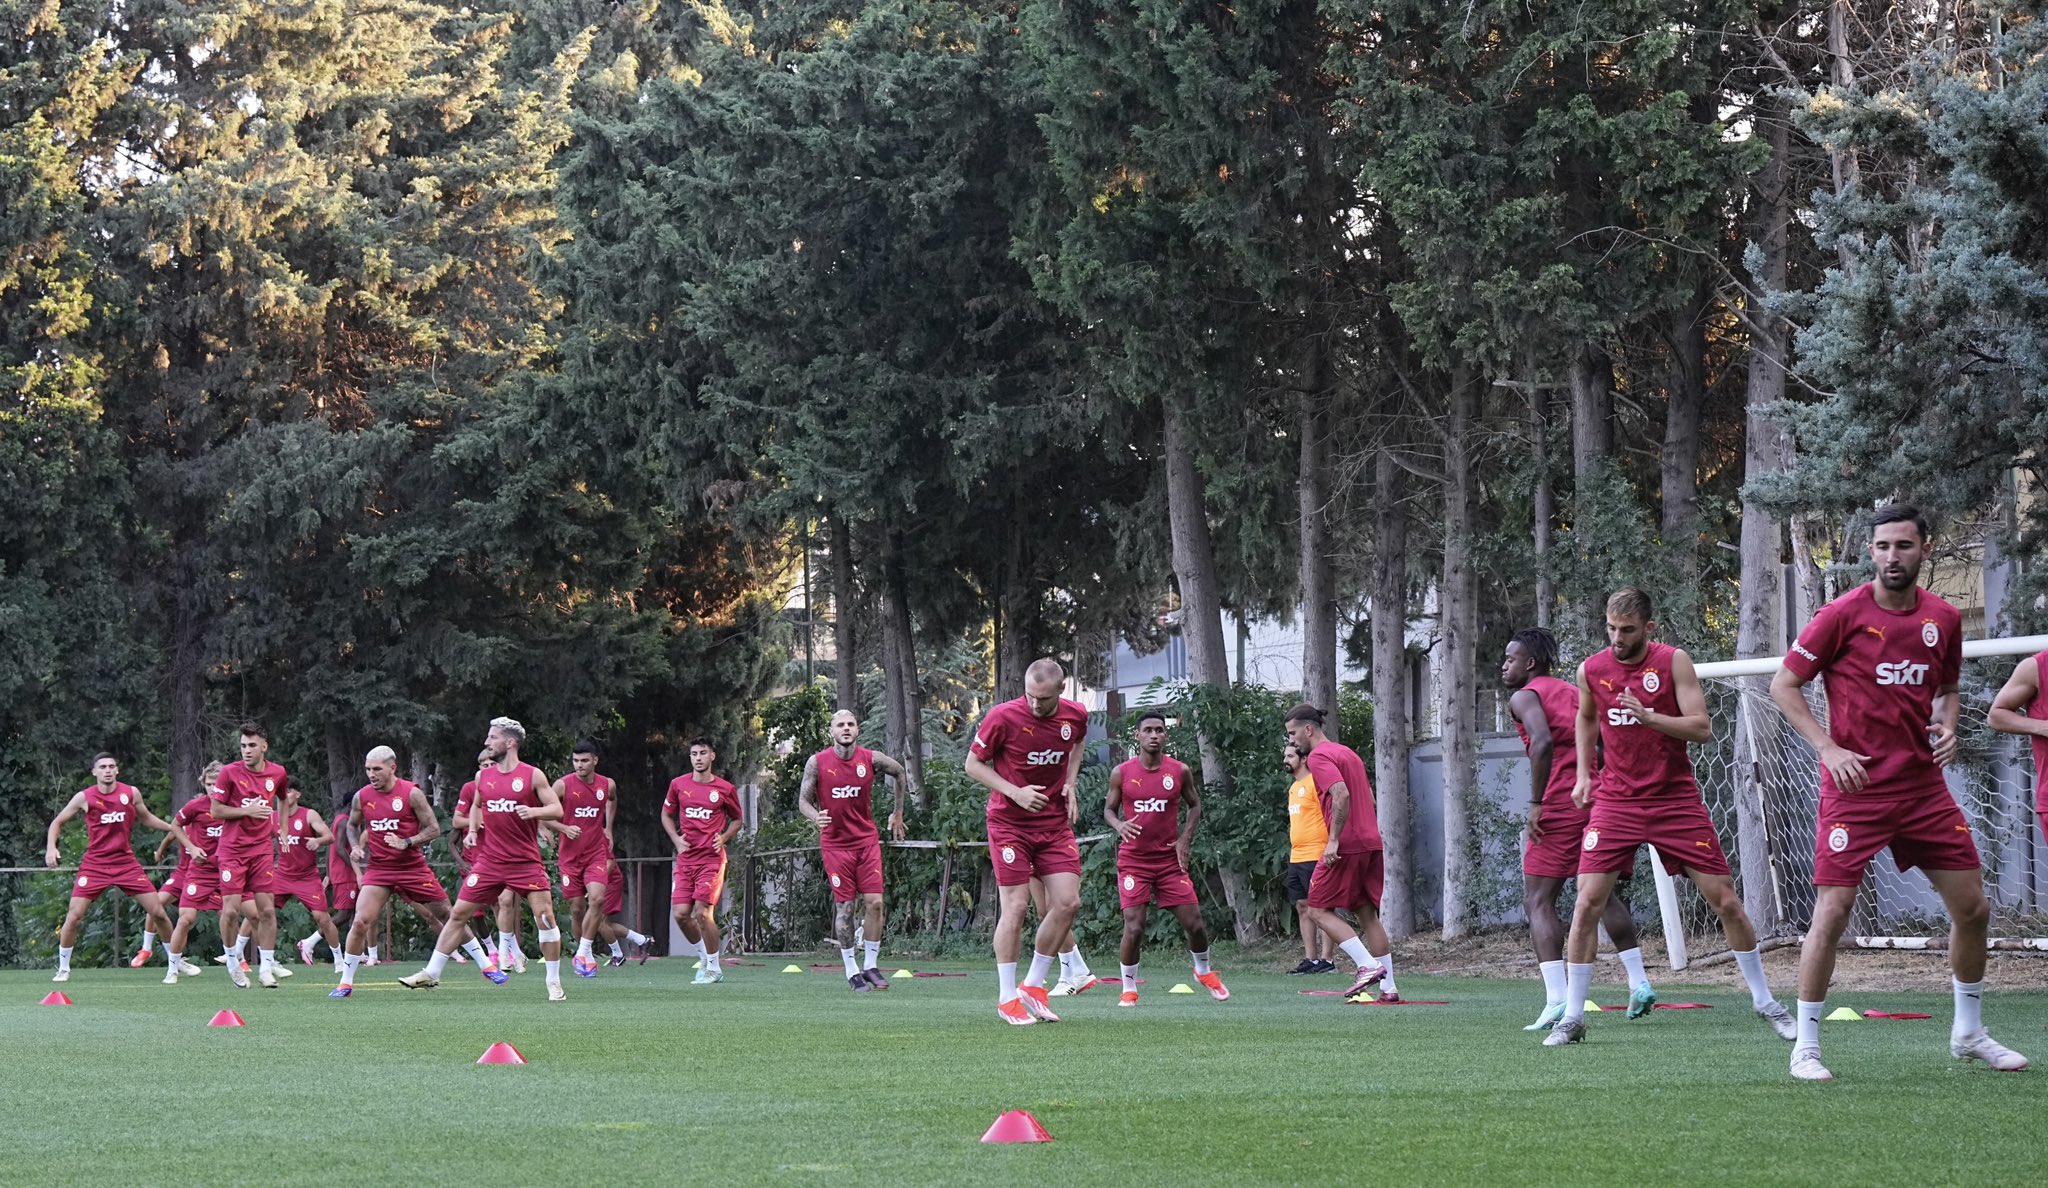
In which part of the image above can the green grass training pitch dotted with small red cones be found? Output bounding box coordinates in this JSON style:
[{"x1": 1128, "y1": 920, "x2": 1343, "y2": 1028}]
[{"x1": 0, "y1": 959, "x2": 2048, "y2": 1188}]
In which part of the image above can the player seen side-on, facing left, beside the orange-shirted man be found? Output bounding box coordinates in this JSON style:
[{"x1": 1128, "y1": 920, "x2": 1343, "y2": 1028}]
[{"x1": 1286, "y1": 703, "x2": 1401, "y2": 1004}]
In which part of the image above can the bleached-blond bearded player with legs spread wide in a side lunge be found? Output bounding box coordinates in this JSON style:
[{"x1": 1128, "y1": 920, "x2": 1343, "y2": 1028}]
[{"x1": 397, "y1": 717, "x2": 567, "y2": 1002}]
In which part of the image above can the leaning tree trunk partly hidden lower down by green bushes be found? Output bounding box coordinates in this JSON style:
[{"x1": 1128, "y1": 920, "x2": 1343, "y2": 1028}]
[{"x1": 1163, "y1": 395, "x2": 1262, "y2": 944}]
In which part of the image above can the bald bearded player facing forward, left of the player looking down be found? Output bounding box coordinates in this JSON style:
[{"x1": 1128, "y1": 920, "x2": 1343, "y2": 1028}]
[{"x1": 797, "y1": 709, "x2": 909, "y2": 991}]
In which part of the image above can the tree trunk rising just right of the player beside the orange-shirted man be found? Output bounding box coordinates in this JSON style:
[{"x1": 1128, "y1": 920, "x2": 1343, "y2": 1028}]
[{"x1": 1372, "y1": 426, "x2": 1415, "y2": 940}]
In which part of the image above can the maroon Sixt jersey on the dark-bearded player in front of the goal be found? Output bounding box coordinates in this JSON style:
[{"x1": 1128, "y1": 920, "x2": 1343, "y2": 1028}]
[{"x1": 1786, "y1": 582, "x2": 1962, "y2": 797}]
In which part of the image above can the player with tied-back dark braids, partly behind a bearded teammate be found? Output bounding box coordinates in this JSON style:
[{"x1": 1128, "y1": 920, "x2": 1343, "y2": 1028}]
[{"x1": 1501, "y1": 627, "x2": 1657, "y2": 1030}]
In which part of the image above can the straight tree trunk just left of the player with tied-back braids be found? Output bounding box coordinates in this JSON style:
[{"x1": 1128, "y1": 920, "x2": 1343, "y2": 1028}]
[{"x1": 1440, "y1": 367, "x2": 1479, "y2": 940}]
